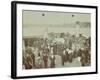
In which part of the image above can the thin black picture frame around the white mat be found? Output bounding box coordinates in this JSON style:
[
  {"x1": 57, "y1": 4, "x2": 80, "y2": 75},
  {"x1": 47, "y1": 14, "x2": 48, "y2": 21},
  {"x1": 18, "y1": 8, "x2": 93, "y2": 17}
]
[{"x1": 11, "y1": 1, "x2": 98, "y2": 79}]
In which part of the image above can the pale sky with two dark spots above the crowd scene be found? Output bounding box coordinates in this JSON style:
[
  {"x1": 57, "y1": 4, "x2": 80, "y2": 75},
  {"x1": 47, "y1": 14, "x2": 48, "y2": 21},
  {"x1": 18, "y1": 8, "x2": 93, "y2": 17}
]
[{"x1": 23, "y1": 10, "x2": 91, "y2": 26}]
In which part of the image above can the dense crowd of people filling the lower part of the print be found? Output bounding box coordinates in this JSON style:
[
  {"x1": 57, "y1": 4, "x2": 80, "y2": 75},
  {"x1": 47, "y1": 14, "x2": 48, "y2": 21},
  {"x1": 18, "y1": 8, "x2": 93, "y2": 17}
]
[{"x1": 23, "y1": 33, "x2": 91, "y2": 69}]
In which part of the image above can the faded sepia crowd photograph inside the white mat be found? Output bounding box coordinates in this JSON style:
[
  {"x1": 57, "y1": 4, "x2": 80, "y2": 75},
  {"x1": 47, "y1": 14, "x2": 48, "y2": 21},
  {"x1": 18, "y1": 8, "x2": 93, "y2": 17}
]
[{"x1": 22, "y1": 10, "x2": 91, "y2": 69}]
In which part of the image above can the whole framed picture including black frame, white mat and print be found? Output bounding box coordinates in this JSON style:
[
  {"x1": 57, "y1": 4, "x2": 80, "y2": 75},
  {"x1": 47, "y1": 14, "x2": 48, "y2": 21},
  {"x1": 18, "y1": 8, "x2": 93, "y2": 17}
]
[{"x1": 11, "y1": 1, "x2": 97, "y2": 79}]
